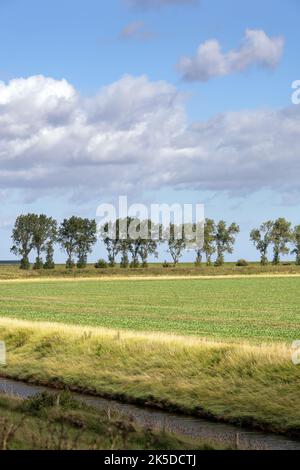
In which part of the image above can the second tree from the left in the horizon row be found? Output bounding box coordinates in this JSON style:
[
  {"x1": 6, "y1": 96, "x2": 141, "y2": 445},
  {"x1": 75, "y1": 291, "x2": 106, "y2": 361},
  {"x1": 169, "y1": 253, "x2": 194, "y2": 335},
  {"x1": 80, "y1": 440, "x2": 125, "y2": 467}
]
[{"x1": 33, "y1": 214, "x2": 57, "y2": 269}]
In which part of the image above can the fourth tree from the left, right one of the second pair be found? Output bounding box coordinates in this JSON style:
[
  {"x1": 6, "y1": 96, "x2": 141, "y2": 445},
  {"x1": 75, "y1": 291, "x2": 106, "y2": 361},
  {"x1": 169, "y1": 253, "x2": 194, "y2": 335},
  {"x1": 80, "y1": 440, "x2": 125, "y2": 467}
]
[{"x1": 76, "y1": 218, "x2": 97, "y2": 268}]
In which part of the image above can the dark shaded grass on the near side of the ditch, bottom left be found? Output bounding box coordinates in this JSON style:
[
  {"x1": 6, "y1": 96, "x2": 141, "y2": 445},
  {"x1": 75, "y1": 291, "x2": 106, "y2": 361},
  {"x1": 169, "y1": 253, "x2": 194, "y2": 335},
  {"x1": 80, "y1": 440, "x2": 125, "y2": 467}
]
[{"x1": 0, "y1": 392, "x2": 218, "y2": 450}]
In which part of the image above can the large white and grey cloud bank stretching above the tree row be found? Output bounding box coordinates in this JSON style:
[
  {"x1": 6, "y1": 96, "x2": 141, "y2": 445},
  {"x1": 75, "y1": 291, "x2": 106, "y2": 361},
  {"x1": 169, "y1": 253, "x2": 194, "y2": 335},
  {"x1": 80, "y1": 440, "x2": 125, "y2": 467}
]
[{"x1": 0, "y1": 76, "x2": 300, "y2": 199}]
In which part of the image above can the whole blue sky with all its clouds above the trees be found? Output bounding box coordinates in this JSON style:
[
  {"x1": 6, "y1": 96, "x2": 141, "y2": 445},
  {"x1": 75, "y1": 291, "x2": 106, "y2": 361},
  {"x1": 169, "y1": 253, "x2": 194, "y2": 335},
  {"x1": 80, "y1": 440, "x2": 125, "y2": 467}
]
[{"x1": 0, "y1": 0, "x2": 300, "y2": 260}]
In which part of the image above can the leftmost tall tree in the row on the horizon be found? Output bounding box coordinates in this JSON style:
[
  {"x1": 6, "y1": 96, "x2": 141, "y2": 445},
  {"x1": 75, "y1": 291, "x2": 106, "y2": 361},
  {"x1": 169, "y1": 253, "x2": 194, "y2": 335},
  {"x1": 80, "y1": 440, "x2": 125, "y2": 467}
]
[{"x1": 11, "y1": 214, "x2": 37, "y2": 269}]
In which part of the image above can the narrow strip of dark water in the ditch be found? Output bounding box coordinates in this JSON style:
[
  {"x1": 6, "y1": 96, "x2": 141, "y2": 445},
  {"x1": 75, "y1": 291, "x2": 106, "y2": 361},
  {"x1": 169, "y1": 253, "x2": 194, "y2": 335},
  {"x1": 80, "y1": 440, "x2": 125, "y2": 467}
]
[{"x1": 0, "y1": 378, "x2": 300, "y2": 450}]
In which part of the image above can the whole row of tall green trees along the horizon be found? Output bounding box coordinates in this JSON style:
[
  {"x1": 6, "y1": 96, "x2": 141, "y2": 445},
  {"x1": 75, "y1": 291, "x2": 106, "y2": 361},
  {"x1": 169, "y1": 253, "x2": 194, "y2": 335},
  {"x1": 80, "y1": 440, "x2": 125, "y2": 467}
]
[{"x1": 11, "y1": 214, "x2": 300, "y2": 269}]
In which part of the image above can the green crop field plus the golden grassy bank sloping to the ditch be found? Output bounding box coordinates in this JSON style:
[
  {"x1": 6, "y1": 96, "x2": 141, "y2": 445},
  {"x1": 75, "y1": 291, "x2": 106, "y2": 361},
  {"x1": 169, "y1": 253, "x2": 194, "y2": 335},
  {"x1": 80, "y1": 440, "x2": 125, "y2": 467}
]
[{"x1": 0, "y1": 276, "x2": 300, "y2": 437}]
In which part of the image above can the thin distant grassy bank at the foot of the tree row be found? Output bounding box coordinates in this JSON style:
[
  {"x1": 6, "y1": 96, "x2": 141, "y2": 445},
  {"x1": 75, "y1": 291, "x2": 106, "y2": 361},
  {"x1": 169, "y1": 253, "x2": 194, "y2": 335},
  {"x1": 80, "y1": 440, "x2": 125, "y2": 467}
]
[{"x1": 0, "y1": 263, "x2": 300, "y2": 280}]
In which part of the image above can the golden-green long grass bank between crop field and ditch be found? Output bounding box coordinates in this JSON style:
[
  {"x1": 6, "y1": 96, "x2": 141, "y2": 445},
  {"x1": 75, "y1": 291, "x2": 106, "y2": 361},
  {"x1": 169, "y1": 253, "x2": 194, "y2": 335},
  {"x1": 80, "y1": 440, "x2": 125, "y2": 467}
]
[{"x1": 0, "y1": 319, "x2": 300, "y2": 437}]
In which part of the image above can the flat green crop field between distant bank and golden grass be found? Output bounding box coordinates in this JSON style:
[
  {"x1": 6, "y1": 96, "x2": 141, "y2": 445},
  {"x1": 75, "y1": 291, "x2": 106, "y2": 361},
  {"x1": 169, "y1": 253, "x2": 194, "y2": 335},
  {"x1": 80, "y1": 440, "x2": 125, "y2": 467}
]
[{"x1": 0, "y1": 277, "x2": 300, "y2": 343}]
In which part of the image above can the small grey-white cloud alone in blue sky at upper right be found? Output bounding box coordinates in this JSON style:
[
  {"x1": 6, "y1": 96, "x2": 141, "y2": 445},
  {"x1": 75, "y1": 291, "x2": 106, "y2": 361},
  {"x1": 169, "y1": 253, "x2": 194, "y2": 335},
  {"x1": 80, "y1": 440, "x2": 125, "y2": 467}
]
[{"x1": 177, "y1": 29, "x2": 284, "y2": 82}]
